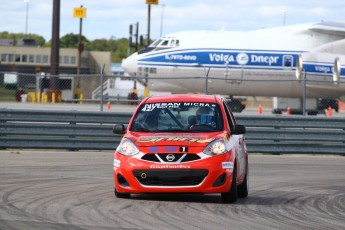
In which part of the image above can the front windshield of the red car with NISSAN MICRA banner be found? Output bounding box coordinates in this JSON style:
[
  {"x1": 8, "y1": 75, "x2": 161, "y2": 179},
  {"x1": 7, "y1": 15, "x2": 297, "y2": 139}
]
[{"x1": 129, "y1": 102, "x2": 223, "y2": 132}]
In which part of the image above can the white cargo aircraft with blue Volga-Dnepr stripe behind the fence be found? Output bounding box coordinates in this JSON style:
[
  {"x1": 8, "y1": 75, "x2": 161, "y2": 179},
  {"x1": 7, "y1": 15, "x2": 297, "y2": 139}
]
[{"x1": 122, "y1": 22, "x2": 345, "y2": 102}]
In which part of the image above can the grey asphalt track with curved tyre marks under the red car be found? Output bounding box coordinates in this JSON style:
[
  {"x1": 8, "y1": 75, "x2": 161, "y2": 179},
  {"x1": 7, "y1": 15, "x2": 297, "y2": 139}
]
[{"x1": 0, "y1": 150, "x2": 345, "y2": 230}]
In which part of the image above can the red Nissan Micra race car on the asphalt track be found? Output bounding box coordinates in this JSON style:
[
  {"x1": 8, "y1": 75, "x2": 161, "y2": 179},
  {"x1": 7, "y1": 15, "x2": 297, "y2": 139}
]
[{"x1": 113, "y1": 94, "x2": 249, "y2": 203}]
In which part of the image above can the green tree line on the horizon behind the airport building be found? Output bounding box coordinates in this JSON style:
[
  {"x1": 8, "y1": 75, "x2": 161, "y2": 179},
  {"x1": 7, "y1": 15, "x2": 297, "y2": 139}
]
[{"x1": 0, "y1": 31, "x2": 143, "y2": 62}]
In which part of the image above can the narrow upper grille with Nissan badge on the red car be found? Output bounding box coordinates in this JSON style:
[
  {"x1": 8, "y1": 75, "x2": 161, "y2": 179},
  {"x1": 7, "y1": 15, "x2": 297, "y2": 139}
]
[{"x1": 141, "y1": 153, "x2": 200, "y2": 163}]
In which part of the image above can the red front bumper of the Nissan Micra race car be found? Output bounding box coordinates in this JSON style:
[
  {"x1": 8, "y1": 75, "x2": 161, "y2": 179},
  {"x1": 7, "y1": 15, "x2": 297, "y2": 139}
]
[{"x1": 113, "y1": 152, "x2": 233, "y2": 193}]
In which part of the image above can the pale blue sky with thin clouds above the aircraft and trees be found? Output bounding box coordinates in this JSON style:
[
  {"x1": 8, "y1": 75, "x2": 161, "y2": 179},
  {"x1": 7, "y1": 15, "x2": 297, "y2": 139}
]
[{"x1": 0, "y1": 0, "x2": 345, "y2": 41}]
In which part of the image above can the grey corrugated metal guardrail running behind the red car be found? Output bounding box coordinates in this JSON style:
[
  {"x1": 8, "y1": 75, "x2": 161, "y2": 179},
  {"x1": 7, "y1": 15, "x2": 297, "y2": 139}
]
[{"x1": 0, "y1": 109, "x2": 345, "y2": 155}]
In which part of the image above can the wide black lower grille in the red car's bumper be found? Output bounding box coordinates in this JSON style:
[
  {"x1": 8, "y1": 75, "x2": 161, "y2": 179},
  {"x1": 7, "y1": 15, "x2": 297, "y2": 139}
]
[{"x1": 133, "y1": 169, "x2": 208, "y2": 186}]
